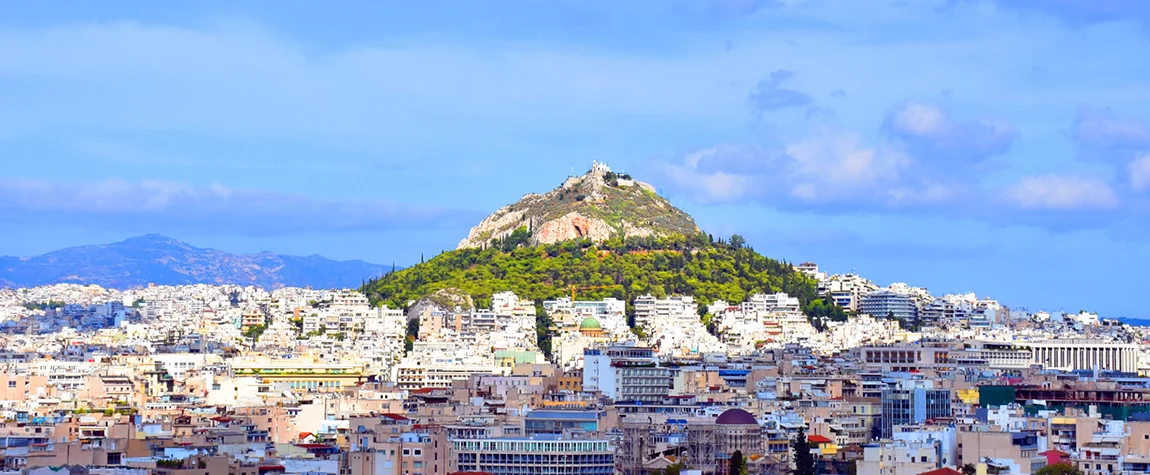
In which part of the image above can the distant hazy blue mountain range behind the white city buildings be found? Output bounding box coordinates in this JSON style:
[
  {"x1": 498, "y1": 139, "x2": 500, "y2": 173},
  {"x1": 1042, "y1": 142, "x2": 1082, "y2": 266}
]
[{"x1": 0, "y1": 235, "x2": 390, "y2": 289}]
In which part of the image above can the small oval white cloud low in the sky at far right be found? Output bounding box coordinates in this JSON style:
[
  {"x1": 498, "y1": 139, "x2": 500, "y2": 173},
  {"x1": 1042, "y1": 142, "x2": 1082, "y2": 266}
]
[{"x1": 1006, "y1": 175, "x2": 1118, "y2": 210}]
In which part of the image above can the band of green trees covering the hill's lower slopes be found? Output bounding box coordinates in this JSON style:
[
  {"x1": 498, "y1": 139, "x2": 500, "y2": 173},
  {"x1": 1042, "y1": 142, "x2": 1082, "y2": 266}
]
[{"x1": 363, "y1": 229, "x2": 842, "y2": 317}]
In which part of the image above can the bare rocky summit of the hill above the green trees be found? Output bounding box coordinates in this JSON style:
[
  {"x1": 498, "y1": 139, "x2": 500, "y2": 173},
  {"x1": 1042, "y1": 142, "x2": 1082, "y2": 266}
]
[{"x1": 459, "y1": 163, "x2": 699, "y2": 248}]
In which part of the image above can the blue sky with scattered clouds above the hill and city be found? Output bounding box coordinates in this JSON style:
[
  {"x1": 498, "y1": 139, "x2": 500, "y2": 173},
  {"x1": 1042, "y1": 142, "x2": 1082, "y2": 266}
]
[{"x1": 0, "y1": 0, "x2": 1150, "y2": 317}]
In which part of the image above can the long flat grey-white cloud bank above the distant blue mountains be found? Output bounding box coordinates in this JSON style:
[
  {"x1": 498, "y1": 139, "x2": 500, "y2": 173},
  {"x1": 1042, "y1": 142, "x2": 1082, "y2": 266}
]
[{"x1": 0, "y1": 178, "x2": 470, "y2": 236}]
